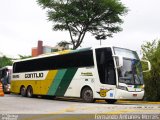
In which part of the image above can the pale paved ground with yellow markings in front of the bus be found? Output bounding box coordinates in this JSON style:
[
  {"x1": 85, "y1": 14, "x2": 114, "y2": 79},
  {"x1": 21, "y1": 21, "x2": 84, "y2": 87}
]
[{"x1": 0, "y1": 95, "x2": 160, "y2": 120}]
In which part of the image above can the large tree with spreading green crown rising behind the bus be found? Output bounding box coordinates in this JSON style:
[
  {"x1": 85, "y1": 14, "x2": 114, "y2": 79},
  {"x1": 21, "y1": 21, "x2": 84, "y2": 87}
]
[{"x1": 37, "y1": 0, "x2": 128, "y2": 49}]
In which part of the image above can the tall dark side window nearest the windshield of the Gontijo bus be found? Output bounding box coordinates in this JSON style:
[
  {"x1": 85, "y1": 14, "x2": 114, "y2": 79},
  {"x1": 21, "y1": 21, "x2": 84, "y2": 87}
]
[{"x1": 96, "y1": 48, "x2": 116, "y2": 85}]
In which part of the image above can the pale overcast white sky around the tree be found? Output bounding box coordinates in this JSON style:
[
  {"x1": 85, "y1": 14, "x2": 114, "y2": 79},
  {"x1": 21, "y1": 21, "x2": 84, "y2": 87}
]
[{"x1": 0, "y1": 0, "x2": 160, "y2": 58}]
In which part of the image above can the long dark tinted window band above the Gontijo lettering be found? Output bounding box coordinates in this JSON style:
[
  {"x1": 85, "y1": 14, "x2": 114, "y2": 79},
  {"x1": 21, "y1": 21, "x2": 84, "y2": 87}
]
[{"x1": 13, "y1": 50, "x2": 94, "y2": 73}]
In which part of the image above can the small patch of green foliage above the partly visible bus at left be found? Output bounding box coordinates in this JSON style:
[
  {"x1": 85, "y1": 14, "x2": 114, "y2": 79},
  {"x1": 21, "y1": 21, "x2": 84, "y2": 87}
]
[{"x1": 0, "y1": 56, "x2": 12, "y2": 68}]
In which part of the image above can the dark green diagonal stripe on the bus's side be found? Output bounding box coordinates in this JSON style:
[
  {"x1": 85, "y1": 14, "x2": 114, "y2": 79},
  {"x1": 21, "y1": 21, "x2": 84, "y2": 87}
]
[{"x1": 56, "y1": 68, "x2": 78, "y2": 96}]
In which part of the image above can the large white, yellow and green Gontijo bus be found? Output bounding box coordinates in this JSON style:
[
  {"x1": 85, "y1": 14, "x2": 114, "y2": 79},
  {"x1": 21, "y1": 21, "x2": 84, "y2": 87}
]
[{"x1": 11, "y1": 46, "x2": 150, "y2": 103}]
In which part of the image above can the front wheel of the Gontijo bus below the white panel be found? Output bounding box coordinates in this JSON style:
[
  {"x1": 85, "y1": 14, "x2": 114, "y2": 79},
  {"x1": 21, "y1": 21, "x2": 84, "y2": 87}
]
[{"x1": 82, "y1": 87, "x2": 95, "y2": 103}]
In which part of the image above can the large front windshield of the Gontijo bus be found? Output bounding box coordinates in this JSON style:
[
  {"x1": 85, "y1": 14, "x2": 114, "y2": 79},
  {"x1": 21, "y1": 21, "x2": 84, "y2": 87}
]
[{"x1": 114, "y1": 48, "x2": 144, "y2": 85}]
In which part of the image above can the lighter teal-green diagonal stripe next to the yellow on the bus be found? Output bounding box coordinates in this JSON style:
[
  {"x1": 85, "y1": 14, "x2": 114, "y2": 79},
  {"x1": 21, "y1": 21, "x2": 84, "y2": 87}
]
[{"x1": 47, "y1": 69, "x2": 67, "y2": 95}]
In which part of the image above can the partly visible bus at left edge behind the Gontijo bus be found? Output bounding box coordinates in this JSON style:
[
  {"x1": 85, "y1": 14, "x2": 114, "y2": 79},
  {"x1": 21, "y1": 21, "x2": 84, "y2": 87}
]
[{"x1": 0, "y1": 66, "x2": 12, "y2": 93}]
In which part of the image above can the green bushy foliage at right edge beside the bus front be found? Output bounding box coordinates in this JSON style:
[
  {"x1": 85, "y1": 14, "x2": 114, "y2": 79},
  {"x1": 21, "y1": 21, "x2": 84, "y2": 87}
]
[{"x1": 141, "y1": 40, "x2": 160, "y2": 101}]
